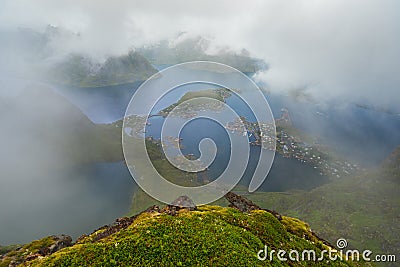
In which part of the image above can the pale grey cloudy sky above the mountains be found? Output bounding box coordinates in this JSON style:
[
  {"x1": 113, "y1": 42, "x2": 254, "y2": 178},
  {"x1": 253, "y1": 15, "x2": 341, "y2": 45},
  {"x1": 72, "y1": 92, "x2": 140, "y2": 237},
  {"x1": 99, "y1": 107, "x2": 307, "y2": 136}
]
[{"x1": 0, "y1": 0, "x2": 400, "y2": 105}]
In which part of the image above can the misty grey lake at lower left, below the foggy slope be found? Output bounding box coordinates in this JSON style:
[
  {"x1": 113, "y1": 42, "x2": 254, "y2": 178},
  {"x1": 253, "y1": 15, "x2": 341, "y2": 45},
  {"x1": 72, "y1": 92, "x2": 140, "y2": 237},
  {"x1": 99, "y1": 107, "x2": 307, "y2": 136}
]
[{"x1": 0, "y1": 162, "x2": 135, "y2": 245}]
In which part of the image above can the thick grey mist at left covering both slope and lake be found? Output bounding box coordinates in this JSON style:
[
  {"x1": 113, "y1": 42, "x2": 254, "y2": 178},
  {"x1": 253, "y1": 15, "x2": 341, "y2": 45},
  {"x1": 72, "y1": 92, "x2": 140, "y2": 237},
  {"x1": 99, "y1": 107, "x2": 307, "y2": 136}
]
[{"x1": 0, "y1": 79, "x2": 135, "y2": 245}]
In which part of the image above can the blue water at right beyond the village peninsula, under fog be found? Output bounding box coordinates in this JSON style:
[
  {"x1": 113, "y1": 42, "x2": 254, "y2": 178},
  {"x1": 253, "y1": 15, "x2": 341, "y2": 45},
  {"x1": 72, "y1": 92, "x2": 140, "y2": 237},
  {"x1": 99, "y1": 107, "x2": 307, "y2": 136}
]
[{"x1": 267, "y1": 94, "x2": 400, "y2": 167}]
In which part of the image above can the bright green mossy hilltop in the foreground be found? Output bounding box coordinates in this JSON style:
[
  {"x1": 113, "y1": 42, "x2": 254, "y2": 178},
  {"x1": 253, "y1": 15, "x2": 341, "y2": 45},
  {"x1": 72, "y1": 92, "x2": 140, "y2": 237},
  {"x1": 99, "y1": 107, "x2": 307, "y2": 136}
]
[{"x1": 2, "y1": 197, "x2": 366, "y2": 266}]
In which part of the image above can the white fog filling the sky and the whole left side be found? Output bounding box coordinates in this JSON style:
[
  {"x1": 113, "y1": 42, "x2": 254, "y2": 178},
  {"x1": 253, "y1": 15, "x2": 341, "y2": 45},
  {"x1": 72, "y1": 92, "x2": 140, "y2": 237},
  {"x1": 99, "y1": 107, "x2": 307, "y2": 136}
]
[{"x1": 0, "y1": 0, "x2": 400, "y2": 247}]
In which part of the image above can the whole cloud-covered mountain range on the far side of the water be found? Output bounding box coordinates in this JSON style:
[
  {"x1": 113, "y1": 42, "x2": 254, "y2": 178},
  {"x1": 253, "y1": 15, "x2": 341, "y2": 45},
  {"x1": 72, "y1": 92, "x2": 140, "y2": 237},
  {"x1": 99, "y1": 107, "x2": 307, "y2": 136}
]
[{"x1": 0, "y1": 25, "x2": 266, "y2": 87}]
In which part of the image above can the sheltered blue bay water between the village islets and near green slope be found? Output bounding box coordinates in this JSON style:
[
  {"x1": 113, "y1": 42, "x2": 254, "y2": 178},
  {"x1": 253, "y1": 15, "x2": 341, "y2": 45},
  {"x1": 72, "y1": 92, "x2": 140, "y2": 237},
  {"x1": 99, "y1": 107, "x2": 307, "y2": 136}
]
[{"x1": 146, "y1": 93, "x2": 328, "y2": 192}]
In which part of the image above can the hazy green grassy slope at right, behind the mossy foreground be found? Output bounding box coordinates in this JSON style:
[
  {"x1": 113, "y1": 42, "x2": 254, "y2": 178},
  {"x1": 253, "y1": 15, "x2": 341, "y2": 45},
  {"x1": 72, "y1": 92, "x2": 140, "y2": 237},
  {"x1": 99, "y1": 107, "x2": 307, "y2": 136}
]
[{"x1": 244, "y1": 148, "x2": 400, "y2": 260}]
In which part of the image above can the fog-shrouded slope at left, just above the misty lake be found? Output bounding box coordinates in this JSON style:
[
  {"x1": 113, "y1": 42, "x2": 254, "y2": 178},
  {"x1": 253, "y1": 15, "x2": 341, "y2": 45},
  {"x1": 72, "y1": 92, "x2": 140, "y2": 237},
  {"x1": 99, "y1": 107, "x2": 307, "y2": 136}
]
[{"x1": 0, "y1": 86, "x2": 123, "y2": 165}]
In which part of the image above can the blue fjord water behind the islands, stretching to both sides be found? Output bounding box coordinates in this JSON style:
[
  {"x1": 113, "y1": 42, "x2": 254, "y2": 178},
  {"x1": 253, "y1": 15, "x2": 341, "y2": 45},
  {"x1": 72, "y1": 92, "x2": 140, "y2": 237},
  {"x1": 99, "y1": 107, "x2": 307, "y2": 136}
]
[{"x1": 55, "y1": 70, "x2": 400, "y2": 166}]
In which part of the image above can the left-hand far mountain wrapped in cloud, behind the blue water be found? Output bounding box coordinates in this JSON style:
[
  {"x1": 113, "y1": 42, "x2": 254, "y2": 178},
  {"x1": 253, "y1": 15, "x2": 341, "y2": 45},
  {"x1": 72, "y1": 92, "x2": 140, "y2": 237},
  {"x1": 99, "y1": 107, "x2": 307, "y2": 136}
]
[{"x1": 0, "y1": 25, "x2": 156, "y2": 87}]
